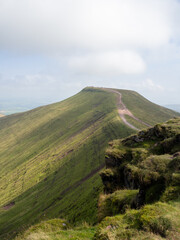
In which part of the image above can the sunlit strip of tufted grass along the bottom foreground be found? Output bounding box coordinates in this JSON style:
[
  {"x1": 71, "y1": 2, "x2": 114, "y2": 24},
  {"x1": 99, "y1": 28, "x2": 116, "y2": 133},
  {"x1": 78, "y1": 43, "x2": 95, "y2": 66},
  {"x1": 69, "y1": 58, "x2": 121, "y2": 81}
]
[{"x1": 14, "y1": 202, "x2": 180, "y2": 240}]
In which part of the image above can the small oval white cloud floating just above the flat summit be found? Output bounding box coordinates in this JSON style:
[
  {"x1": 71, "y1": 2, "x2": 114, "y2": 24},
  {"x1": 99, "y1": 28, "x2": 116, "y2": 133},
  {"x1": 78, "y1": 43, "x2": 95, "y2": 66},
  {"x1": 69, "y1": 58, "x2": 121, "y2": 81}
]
[{"x1": 68, "y1": 51, "x2": 146, "y2": 76}]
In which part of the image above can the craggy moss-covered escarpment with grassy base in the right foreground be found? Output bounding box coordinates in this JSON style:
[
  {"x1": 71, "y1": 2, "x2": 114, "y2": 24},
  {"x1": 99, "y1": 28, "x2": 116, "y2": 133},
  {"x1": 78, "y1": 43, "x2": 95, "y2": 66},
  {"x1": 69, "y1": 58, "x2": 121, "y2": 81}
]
[{"x1": 96, "y1": 118, "x2": 180, "y2": 239}]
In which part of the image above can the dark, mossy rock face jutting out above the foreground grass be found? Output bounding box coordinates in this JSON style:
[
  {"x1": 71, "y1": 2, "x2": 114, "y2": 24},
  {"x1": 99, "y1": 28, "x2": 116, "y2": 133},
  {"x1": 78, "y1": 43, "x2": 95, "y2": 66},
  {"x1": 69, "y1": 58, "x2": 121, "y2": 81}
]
[{"x1": 99, "y1": 118, "x2": 180, "y2": 220}]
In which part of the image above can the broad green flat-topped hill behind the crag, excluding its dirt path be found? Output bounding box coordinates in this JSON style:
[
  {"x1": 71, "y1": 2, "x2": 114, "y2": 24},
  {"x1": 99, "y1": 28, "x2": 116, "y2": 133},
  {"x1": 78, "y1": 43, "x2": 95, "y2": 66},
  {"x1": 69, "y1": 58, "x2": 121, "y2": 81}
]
[{"x1": 0, "y1": 88, "x2": 178, "y2": 239}]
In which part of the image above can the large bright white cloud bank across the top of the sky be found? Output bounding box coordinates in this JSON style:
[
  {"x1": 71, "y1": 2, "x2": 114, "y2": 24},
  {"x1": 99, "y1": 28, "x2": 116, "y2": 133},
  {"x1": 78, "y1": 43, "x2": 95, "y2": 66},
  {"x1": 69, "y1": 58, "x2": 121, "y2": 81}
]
[{"x1": 0, "y1": 0, "x2": 176, "y2": 52}]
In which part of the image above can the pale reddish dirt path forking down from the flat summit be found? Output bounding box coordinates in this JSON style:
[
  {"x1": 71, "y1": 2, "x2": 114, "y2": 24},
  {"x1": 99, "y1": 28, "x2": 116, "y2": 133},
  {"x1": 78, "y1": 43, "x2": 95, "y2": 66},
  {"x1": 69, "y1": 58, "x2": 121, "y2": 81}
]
[{"x1": 103, "y1": 88, "x2": 151, "y2": 131}]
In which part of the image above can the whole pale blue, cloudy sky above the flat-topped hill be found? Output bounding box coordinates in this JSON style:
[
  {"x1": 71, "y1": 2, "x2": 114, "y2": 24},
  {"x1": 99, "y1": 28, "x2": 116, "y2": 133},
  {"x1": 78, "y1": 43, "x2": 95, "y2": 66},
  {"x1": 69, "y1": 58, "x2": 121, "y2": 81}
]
[{"x1": 0, "y1": 0, "x2": 180, "y2": 105}]
